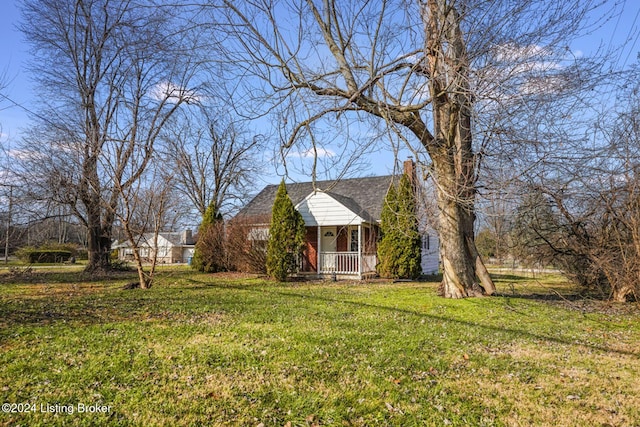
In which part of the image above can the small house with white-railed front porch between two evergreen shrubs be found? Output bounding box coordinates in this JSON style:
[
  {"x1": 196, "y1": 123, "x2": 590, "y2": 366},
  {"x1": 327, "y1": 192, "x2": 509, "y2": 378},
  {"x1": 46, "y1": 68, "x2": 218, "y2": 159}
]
[{"x1": 236, "y1": 161, "x2": 439, "y2": 278}]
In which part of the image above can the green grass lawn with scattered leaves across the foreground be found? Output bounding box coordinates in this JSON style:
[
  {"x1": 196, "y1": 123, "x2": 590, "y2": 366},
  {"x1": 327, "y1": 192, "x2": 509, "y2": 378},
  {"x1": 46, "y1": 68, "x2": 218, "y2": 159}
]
[{"x1": 0, "y1": 269, "x2": 640, "y2": 426}]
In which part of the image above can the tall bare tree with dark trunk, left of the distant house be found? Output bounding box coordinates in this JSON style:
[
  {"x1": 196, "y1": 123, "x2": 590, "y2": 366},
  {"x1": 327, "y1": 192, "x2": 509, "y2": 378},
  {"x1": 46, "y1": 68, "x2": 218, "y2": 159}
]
[{"x1": 21, "y1": 0, "x2": 196, "y2": 271}]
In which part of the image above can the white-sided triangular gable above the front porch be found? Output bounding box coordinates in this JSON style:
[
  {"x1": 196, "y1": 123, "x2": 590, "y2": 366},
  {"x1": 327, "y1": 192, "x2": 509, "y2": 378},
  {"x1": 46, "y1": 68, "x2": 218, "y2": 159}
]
[{"x1": 296, "y1": 191, "x2": 364, "y2": 227}]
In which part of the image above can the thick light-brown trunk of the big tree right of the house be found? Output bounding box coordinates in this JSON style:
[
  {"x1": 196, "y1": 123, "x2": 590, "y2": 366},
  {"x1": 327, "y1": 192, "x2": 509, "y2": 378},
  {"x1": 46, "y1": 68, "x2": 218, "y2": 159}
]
[{"x1": 424, "y1": 0, "x2": 495, "y2": 298}]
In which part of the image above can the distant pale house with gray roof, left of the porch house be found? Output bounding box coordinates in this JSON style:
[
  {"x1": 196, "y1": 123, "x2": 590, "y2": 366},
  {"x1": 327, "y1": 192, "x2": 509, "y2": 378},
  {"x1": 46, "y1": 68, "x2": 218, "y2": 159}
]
[{"x1": 113, "y1": 230, "x2": 195, "y2": 264}]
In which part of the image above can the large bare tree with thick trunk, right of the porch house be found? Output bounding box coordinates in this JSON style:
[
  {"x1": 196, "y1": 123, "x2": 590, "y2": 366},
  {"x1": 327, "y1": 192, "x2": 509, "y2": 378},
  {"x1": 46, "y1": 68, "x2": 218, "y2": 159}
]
[{"x1": 212, "y1": 0, "x2": 602, "y2": 298}]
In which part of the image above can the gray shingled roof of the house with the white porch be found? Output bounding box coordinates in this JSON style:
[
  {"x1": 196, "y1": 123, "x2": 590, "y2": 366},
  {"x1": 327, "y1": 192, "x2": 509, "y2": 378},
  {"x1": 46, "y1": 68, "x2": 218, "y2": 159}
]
[{"x1": 238, "y1": 175, "x2": 398, "y2": 221}]
